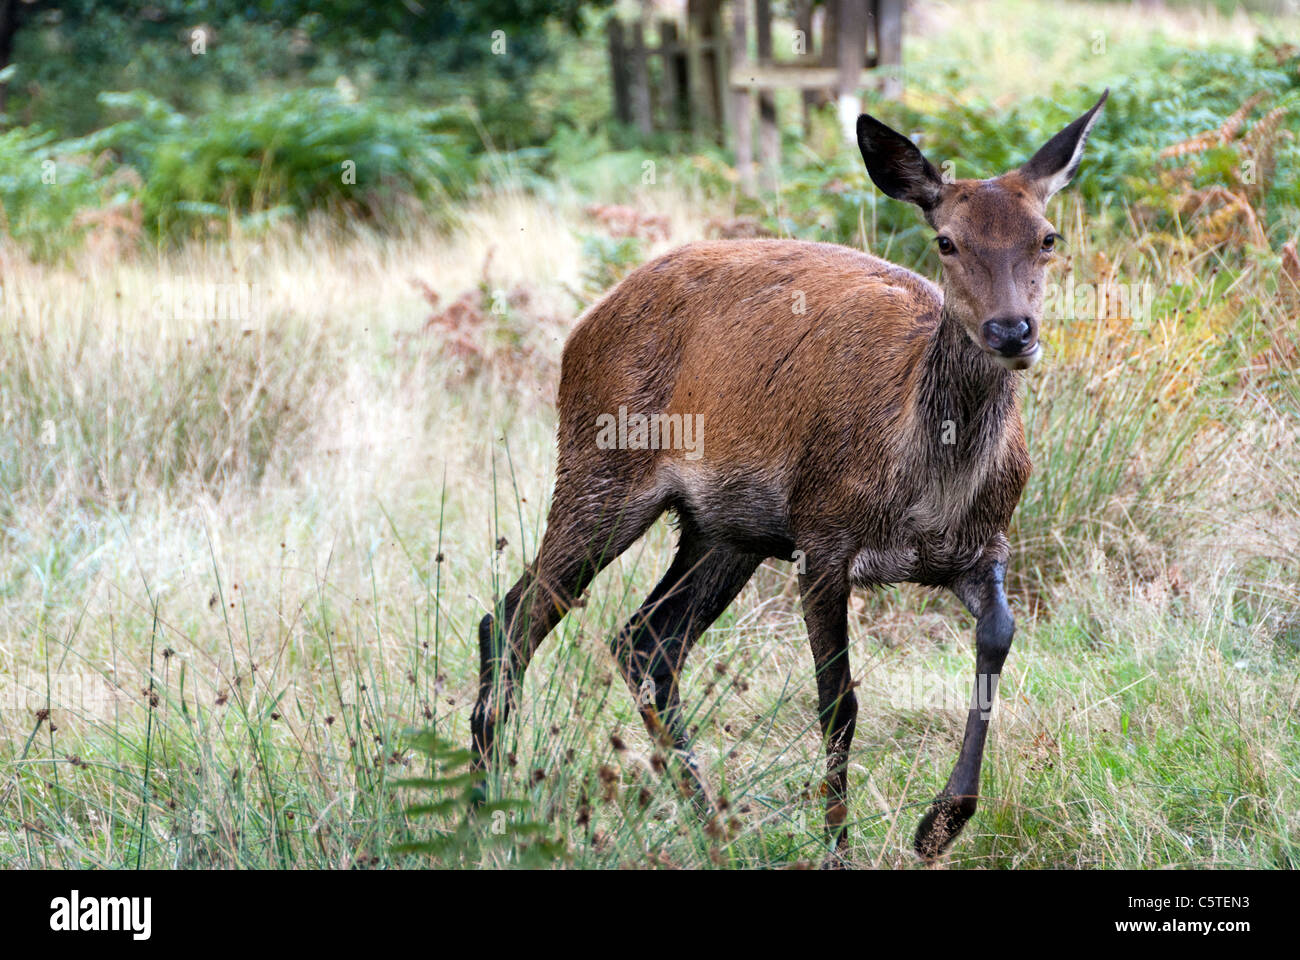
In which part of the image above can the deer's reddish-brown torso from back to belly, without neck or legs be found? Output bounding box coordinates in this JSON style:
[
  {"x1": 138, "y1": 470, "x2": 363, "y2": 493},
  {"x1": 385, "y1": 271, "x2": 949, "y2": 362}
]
[{"x1": 559, "y1": 241, "x2": 943, "y2": 553}]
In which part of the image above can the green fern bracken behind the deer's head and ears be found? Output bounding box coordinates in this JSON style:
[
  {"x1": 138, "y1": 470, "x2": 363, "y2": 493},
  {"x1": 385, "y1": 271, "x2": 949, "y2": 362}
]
[{"x1": 767, "y1": 43, "x2": 1300, "y2": 261}]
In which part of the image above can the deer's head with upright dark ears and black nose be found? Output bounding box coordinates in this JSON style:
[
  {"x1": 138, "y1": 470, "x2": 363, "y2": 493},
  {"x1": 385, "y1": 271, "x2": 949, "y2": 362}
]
[{"x1": 858, "y1": 91, "x2": 1110, "y2": 369}]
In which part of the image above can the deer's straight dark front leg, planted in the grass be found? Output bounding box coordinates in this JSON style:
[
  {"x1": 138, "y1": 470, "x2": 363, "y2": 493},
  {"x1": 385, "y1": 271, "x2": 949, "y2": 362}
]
[{"x1": 800, "y1": 565, "x2": 858, "y2": 852}]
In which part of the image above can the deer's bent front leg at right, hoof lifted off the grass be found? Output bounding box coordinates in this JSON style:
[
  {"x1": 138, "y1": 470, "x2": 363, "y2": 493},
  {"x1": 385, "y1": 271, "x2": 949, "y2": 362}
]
[{"x1": 915, "y1": 559, "x2": 1015, "y2": 860}]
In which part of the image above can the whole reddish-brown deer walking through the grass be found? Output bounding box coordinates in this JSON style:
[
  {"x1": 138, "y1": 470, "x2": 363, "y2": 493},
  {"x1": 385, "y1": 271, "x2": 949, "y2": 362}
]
[{"x1": 471, "y1": 91, "x2": 1109, "y2": 860}]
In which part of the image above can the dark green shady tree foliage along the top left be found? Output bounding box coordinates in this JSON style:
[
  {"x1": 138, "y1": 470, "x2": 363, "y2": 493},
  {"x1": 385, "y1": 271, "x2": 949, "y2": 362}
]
[{"x1": 0, "y1": 0, "x2": 610, "y2": 134}]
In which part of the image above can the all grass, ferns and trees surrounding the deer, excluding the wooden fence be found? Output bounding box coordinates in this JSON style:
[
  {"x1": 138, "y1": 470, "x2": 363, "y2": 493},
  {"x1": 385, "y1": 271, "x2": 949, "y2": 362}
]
[{"x1": 0, "y1": 0, "x2": 1300, "y2": 868}]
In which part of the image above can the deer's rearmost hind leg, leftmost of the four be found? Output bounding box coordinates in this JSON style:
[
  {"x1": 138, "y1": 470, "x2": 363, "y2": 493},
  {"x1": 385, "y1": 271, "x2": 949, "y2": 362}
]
[{"x1": 469, "y1": 490, "x2": 663, "y2": 770}]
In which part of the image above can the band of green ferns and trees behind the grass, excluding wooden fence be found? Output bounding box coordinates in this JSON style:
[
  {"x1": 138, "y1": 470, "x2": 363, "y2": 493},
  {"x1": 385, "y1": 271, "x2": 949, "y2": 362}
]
[{"x1": 0, "y1": 0, "x2": 1300, "y2": 261}]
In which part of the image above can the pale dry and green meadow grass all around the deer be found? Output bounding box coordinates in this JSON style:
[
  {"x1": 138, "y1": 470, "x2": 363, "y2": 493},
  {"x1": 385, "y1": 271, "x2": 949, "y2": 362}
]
[{"x1": 0, "y1": 4, "x2": 1300, "y2": 869}]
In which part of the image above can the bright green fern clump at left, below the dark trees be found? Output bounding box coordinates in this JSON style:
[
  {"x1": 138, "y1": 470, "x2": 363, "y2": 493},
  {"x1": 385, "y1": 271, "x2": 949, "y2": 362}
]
[{"x1": 86, "y1": 90, "x2": 476, "y2": 237}]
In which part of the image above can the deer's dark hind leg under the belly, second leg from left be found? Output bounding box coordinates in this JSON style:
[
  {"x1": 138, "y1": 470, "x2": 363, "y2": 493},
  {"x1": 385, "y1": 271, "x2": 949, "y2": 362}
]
[{"x1": 610, "y1": 524, "x2": 762, "y2": 799}]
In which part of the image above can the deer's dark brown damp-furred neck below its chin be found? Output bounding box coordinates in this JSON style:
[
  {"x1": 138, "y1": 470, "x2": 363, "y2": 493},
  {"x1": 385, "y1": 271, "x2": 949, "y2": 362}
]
[{"x1": 915, "y1": 307, "x2": 1021, "y2": 471}]
